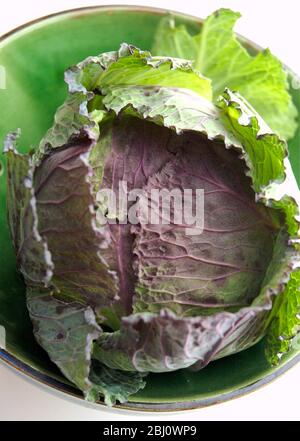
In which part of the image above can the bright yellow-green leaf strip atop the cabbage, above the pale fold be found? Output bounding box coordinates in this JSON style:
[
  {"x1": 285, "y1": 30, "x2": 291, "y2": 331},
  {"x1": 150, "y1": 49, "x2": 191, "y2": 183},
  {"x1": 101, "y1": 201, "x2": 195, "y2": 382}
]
[{"x1": 66, "y1": 43, "x2": 212, "y2": 99}]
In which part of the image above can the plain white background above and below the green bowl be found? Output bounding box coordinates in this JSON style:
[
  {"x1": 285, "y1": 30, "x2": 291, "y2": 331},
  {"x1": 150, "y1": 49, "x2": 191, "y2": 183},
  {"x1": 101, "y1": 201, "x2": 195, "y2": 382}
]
[{"x1": 0, "y1": 0, "x2": 300, "y2": 421}]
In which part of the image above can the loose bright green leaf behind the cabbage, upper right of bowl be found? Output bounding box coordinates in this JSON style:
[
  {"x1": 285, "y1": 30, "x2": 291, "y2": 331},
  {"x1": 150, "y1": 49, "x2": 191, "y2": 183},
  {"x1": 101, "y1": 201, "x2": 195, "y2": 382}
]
[{"x1": 152, "y1": 9, "x2": 297, "y2": 138}]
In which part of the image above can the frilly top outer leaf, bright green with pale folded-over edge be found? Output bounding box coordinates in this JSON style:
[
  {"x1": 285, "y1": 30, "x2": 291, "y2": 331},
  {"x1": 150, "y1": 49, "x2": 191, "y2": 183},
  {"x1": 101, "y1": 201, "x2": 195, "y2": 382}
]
[{"x1": 34, "y1": 43, "x2": 234, "y2": 163}]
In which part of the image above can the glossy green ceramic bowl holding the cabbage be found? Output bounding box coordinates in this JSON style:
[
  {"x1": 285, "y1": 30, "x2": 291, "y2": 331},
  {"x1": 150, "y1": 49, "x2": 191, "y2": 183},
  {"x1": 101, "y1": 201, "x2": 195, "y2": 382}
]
[{"x1": 0, "y1": 6, "x2": 300, "y2": 411}]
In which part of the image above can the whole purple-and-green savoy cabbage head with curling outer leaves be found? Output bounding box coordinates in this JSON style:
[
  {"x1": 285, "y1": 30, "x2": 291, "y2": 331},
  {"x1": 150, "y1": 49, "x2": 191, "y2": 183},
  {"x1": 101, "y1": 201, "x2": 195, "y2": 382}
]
[{"x1": 6, "y1": 44, "x2": 300, "y2": 405}]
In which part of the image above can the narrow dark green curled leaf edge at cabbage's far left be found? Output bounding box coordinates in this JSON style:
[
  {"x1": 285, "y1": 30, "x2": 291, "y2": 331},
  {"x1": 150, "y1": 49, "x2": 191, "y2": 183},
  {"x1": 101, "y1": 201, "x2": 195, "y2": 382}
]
[{"x1": 5, "y1": 133, "x2": 53, "y2": 285}]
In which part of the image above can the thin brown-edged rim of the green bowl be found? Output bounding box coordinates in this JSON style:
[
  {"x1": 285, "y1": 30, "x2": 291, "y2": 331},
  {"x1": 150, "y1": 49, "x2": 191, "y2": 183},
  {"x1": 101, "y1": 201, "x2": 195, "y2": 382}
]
[{"x1": 0, "y1": 4, "x2": 300, "y2": 412}]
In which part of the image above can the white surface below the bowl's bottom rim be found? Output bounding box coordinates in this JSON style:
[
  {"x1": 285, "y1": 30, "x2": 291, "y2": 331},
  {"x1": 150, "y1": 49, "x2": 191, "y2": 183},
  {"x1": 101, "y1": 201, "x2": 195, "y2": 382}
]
[{"x1": 0, "y1": 363, "x2": 300, "y2": 421}]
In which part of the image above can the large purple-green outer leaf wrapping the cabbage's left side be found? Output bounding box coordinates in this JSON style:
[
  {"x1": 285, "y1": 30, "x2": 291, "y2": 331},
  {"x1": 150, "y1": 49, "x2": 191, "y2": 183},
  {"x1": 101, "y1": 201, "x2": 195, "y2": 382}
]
[{"x1": 5, "y1": 134, "x2": 144, "y2": 405}]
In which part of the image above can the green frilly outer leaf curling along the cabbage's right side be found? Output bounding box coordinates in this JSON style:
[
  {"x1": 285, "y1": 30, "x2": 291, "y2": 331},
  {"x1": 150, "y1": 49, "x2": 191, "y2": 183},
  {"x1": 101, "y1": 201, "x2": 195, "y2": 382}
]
[{"x1": 220, "y1": 90, "x2": 300, "y2": 363}]
